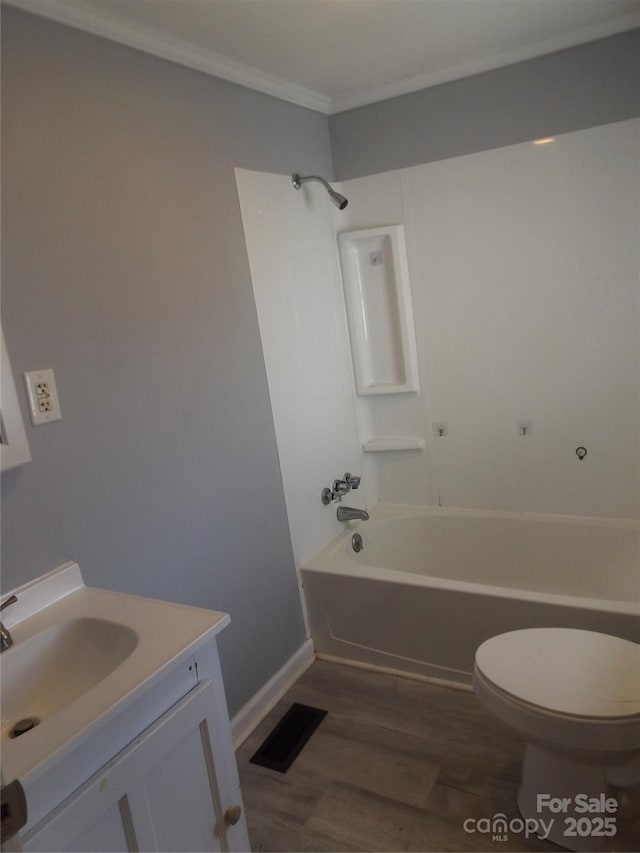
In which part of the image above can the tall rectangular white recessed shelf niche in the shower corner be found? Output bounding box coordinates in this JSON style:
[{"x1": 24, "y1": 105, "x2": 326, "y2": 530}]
[{"x1": 338, "y1": 225, "x2": 418, "y2": 395}]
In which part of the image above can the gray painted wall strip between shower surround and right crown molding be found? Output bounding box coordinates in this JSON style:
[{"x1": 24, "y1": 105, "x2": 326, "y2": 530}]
[{"x1": 329, "y1": 30, "x2": 640, "y2": 180}]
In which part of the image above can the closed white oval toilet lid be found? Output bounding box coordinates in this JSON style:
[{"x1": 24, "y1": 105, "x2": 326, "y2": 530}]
[{"x1": 476, "y1": 628, "x2": 640, "y2": 718}]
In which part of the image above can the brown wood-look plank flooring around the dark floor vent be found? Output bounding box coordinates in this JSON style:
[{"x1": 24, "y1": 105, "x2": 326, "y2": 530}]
[{"x1": 237, "y1": 660, "x2": 640, "y2": 853}]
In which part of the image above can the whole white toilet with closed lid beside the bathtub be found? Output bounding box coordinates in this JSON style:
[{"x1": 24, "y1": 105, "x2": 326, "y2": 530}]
[{"x1": 473, "y1": 628, "x2": 640, "y2": 850}]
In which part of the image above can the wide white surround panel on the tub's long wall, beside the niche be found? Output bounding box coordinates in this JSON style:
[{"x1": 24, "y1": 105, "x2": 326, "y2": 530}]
[{"x1": 334, "y1": 119, "x2": 640, "y2": 518}]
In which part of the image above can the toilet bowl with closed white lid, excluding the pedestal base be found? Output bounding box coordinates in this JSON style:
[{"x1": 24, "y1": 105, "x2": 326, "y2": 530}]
[{"x1": 473, "y1": 628, "x2": 640, "y2": 758}]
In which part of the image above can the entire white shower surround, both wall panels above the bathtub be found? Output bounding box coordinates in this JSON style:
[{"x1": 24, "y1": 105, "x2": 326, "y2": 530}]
[{"x1": 237, "y1": 119, "x2": 640, "y2": 566}]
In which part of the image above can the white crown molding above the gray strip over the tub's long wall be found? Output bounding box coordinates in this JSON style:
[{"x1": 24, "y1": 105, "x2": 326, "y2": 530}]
[{"x1": 329, "y1": 12, "x2": 640, "y2": 115}]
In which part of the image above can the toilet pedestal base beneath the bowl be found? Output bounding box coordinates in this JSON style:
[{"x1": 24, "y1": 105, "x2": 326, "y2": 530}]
[{"x1": 518, "y1": 743, "x2": 617, "y2": 852}]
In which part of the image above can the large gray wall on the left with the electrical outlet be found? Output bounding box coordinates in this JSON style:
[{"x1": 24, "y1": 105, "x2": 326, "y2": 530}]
[{"x1": 2, "y1": 7, "x2": 331, "y2": 713}]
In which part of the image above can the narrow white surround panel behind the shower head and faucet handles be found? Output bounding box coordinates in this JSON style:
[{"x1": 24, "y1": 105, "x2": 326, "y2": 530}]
[{"x1": 236, "y1": 169, "x2": 366, "y2": 566}]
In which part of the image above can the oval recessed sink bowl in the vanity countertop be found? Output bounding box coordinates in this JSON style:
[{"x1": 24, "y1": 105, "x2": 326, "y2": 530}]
[{"x1": 0, "y1": 617, "x2": 138, "y2": 740}]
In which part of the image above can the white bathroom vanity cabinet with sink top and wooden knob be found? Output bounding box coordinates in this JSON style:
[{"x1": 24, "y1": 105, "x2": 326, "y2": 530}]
[{"x1": 0, "y1": 563, "x2": 249, "y2": 851}]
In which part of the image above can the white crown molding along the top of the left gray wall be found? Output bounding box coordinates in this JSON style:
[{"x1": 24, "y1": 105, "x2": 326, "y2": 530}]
[{"x1": 2, "y1": 0, "x2": 330, "y2": 115}]
